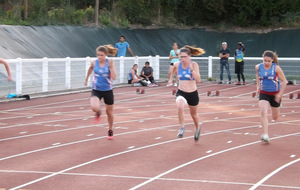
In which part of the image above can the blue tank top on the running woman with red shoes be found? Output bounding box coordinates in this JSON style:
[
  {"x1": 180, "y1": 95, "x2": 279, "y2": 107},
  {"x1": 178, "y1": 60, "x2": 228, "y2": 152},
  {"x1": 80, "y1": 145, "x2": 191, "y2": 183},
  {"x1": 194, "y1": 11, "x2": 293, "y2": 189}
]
[{"x1": 92, "y1": 59, "x2": 113, "y2": 91}]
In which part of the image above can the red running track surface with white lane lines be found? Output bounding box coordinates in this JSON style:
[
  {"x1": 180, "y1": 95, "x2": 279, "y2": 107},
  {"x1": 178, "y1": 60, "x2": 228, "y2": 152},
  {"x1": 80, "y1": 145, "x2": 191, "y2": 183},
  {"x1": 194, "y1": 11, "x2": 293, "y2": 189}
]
[{"x1": 0, "y1": 83, "x2": 300, "y2": 190}]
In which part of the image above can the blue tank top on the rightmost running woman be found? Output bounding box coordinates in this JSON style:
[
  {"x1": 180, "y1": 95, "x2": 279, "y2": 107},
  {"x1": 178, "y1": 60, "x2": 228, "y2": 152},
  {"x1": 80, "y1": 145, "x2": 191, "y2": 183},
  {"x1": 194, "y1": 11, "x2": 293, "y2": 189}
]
[{"x1": 258, "y1": 63, "x2": 280, "y2": 92}]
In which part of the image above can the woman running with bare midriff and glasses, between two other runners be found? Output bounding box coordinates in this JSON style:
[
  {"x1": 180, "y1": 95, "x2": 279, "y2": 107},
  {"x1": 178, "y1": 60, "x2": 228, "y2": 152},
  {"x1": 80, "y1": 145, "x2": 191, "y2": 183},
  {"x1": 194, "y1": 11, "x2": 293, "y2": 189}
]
[{"x1": 168, "y1": 46, "x2": 205, "y2": 141}]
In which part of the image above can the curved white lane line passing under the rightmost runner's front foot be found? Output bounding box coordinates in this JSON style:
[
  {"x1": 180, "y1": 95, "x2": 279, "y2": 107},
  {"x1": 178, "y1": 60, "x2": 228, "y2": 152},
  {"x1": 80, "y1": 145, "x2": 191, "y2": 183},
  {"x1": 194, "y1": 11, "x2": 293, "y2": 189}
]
[{"x1": 130, "y1": 133, "x2": 300, "y2": 190}]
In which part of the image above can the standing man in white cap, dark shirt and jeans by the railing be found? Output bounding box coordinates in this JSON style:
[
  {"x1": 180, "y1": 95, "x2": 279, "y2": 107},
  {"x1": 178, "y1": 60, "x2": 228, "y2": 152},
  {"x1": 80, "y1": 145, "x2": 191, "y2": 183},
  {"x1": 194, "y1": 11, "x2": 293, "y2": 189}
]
[{"x1": 219, "y1": 42, "x2": 231, "y2": 84}]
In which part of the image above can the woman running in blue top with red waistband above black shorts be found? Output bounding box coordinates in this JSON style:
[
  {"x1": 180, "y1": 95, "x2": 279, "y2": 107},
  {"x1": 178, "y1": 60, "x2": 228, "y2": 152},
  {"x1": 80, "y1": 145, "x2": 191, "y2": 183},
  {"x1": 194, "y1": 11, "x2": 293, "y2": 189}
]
[{"x1": 255, "y1": 50, "x2": 287, "y2": 143}]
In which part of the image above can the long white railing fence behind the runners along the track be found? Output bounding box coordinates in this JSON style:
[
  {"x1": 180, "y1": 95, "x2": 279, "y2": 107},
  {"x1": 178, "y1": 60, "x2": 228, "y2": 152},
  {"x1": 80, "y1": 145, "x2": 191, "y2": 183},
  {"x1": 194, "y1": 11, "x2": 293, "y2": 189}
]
[{"x1": 0, "y1": 56, "x2": 300, "y2": 97}]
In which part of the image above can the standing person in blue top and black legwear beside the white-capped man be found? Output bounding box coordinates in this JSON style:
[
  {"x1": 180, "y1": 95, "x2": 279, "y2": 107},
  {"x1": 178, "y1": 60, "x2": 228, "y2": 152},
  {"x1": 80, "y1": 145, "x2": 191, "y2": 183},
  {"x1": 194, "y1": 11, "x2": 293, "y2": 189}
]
[{"x1": 234, "y1": 42, "x2": 246, "y2": 85}]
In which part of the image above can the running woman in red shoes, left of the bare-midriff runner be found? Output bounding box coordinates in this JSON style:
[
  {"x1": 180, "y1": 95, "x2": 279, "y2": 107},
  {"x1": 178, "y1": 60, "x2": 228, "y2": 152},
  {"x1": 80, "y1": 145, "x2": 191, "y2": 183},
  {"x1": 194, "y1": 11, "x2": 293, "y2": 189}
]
[{"x1": 84, "y1": 45, "x2": 117, "y2": 140}]
